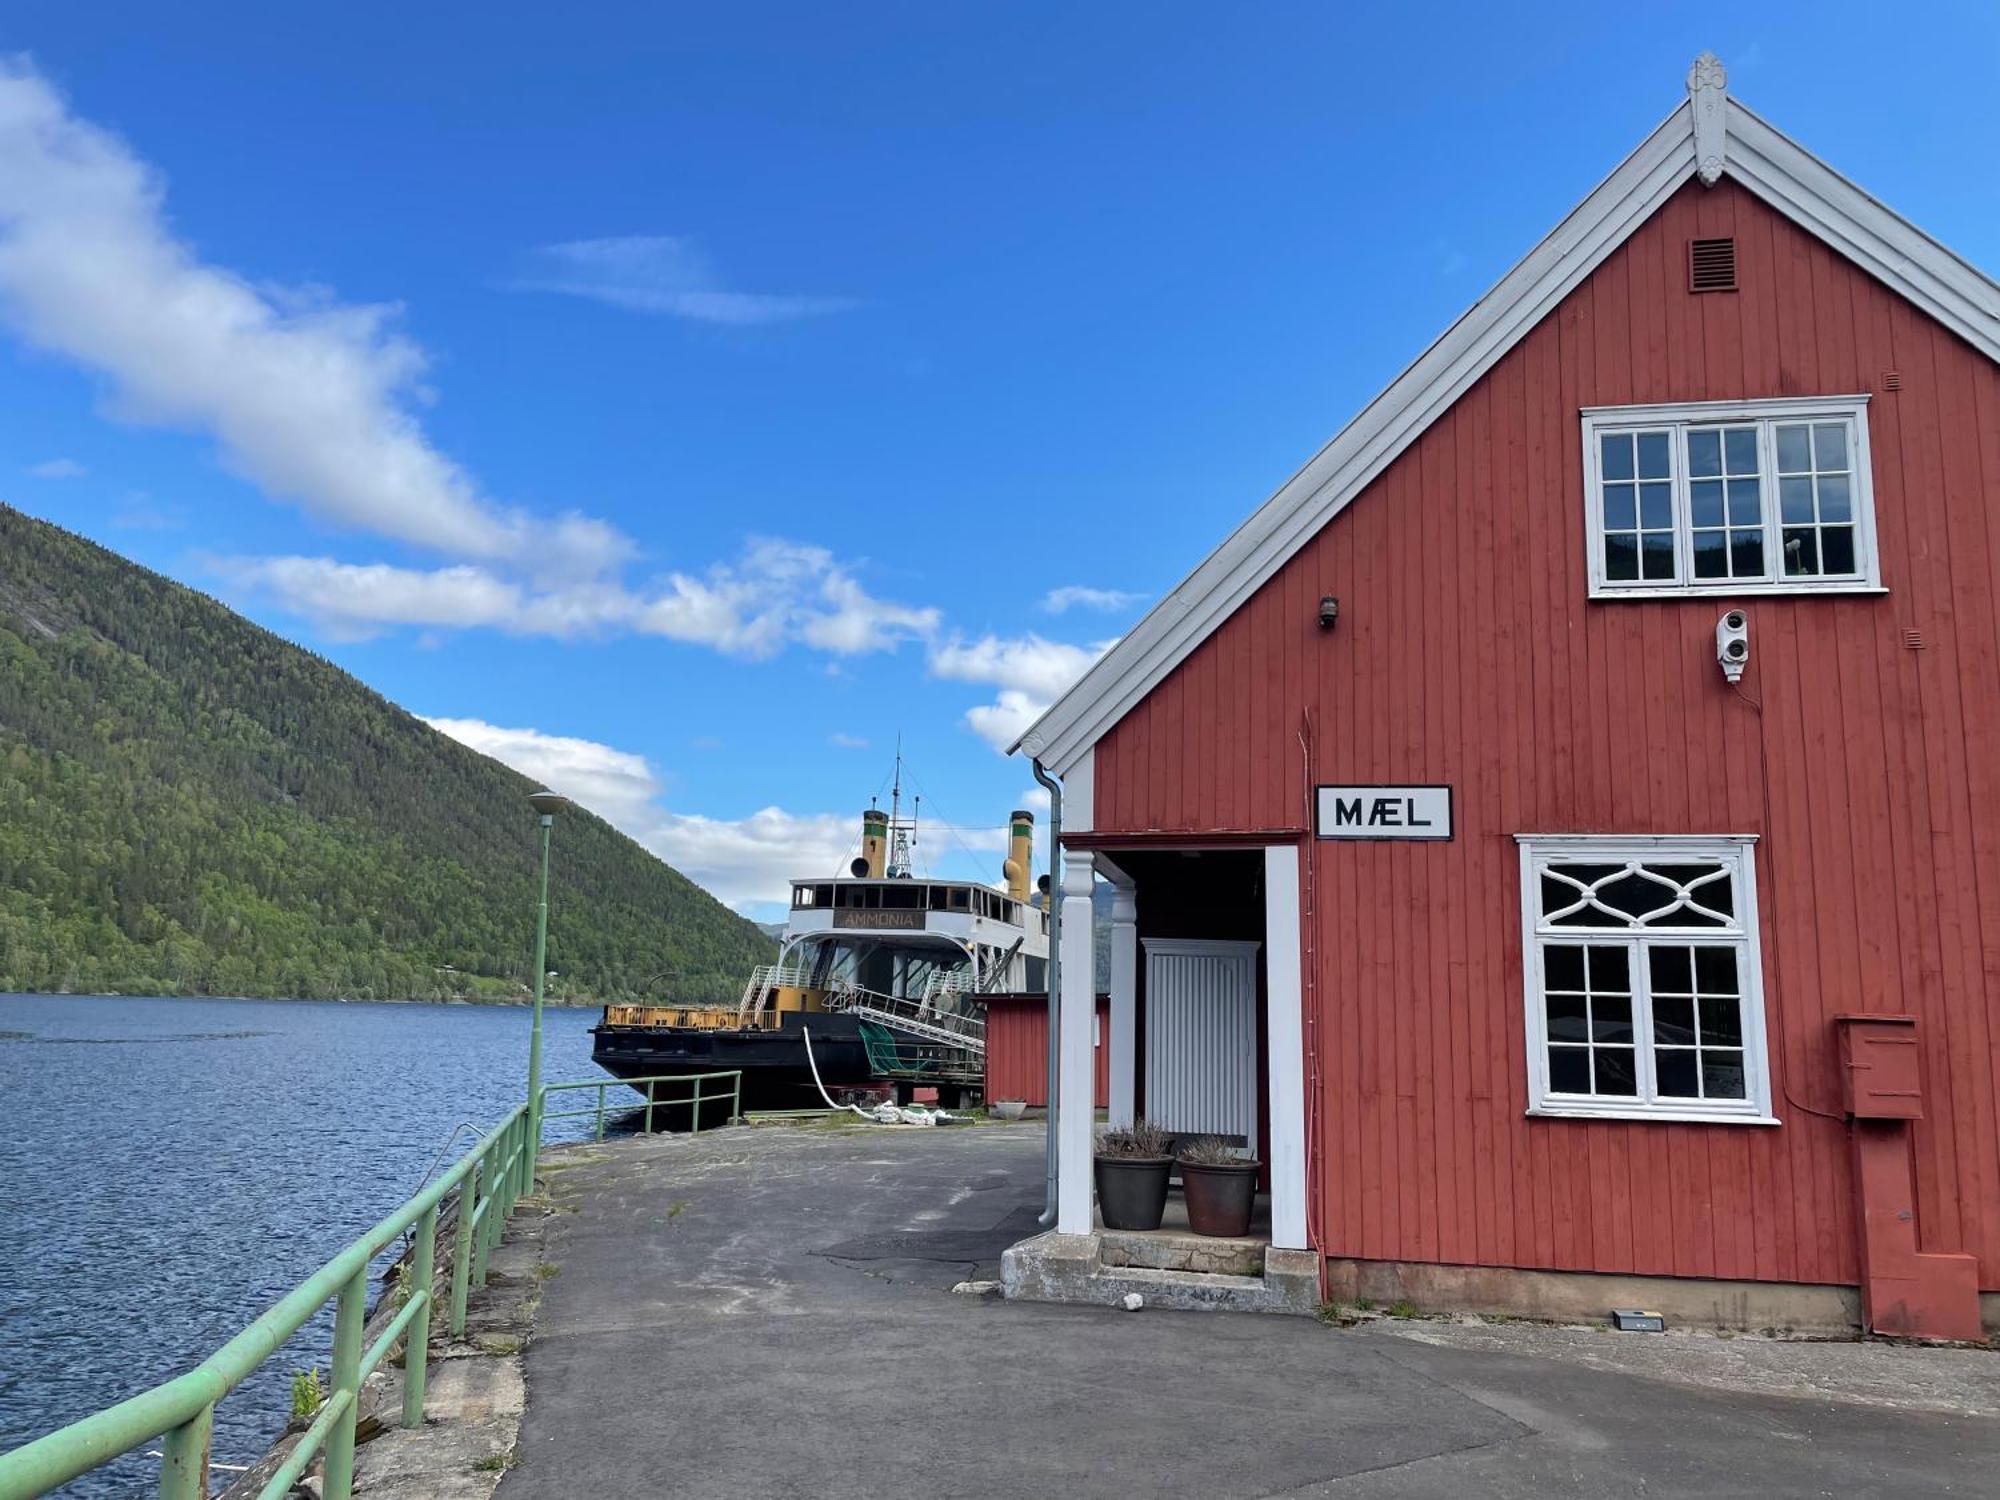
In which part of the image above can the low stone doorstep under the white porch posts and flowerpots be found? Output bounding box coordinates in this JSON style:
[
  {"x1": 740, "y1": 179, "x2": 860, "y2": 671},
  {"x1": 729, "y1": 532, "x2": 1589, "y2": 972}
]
[{"x1": 1000, "y1": 1232, "x2": 1320, "y2": 1314}]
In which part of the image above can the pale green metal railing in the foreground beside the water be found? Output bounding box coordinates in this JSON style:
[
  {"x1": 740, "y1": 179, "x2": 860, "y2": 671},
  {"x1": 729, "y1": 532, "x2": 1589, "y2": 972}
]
[{"x1": 0, "y1": 1104, "x2": 534, "y2": 1500}]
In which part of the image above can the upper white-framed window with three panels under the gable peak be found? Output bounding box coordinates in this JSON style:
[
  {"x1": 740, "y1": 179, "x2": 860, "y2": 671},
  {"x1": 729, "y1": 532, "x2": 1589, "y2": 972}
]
[{"x1": 1584, "y1": 396, "x2": 1882, "y2": 598}]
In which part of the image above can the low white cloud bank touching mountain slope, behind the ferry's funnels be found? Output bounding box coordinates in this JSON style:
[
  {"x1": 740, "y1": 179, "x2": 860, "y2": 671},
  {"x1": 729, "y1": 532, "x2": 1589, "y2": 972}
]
[{"x1": 426, "y1": 718, "x2": 1006, "y2": 908}]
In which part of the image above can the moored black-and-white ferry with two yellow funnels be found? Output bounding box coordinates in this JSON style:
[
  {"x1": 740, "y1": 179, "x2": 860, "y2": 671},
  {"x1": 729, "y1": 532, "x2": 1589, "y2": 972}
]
[{"x1": 592, "y1": 788, "x2": 1048, "y2": 1110}]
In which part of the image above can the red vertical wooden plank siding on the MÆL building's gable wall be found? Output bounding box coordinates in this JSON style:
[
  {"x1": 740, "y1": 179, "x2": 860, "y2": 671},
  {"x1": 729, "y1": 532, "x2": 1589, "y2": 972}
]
[{"x1": 1094, "y1": 180, "x2": 2000, "y2": 1288}]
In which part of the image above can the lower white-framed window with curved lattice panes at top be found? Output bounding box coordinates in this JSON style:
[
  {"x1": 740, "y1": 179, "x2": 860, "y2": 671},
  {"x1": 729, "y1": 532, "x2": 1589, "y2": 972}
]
[{"x1": 1518, "y1": 834, "x2": 1776, "y2": 1124}]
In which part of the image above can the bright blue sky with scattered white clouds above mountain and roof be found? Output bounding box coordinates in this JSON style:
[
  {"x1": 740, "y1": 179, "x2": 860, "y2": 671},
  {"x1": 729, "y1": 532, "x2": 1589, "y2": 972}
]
[{"x1": 0, "y1": 0, "x2": 2000, "y2": 914}]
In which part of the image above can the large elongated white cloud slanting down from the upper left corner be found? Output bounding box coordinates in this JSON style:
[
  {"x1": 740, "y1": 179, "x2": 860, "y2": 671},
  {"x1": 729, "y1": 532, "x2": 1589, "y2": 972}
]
[{"x1": 0, "y1": 58, "x2": 630, "y2": 574}]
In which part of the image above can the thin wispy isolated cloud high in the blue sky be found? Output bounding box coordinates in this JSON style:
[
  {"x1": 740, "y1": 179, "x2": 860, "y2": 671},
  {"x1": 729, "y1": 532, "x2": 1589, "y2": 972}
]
[{"x1": 508, "y1": 234, "x2": 854, "y2": 326}]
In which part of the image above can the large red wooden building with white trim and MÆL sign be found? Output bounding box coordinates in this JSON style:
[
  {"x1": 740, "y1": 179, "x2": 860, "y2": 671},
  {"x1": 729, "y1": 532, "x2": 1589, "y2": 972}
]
[{"x1": 1020, "y1": 56, "x2": 2000, "y2": 1336}]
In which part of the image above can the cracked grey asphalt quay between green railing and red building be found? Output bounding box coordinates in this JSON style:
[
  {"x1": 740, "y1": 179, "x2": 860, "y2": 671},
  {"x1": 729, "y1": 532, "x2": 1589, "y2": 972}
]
[{"x1": 498, "y1": 1124, "x2": 2000, "y2": 1500}]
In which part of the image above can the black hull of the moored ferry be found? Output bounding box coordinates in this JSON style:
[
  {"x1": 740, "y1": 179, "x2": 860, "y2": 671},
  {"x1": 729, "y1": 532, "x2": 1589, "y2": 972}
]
[{"x1": 590, "y1": 1012, "x2": 872, "y2": 1128}]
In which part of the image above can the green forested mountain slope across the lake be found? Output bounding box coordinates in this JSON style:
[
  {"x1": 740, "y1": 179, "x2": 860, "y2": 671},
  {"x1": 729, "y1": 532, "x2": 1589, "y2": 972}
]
[{"x1": 0, "y1": 506, "x2": 774, "y2": 1000}]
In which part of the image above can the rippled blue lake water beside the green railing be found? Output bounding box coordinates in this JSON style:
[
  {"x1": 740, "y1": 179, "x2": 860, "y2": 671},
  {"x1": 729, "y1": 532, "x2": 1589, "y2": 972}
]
[{"x1": 0, "y1": 996, "x2": 602, "y2": 1496}]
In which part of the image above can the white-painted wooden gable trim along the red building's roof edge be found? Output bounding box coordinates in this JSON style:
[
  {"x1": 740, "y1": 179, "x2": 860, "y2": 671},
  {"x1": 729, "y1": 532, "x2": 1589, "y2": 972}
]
[{"x1": 1012, "y1": 52, "x2": 2000, "y2": 776}]
